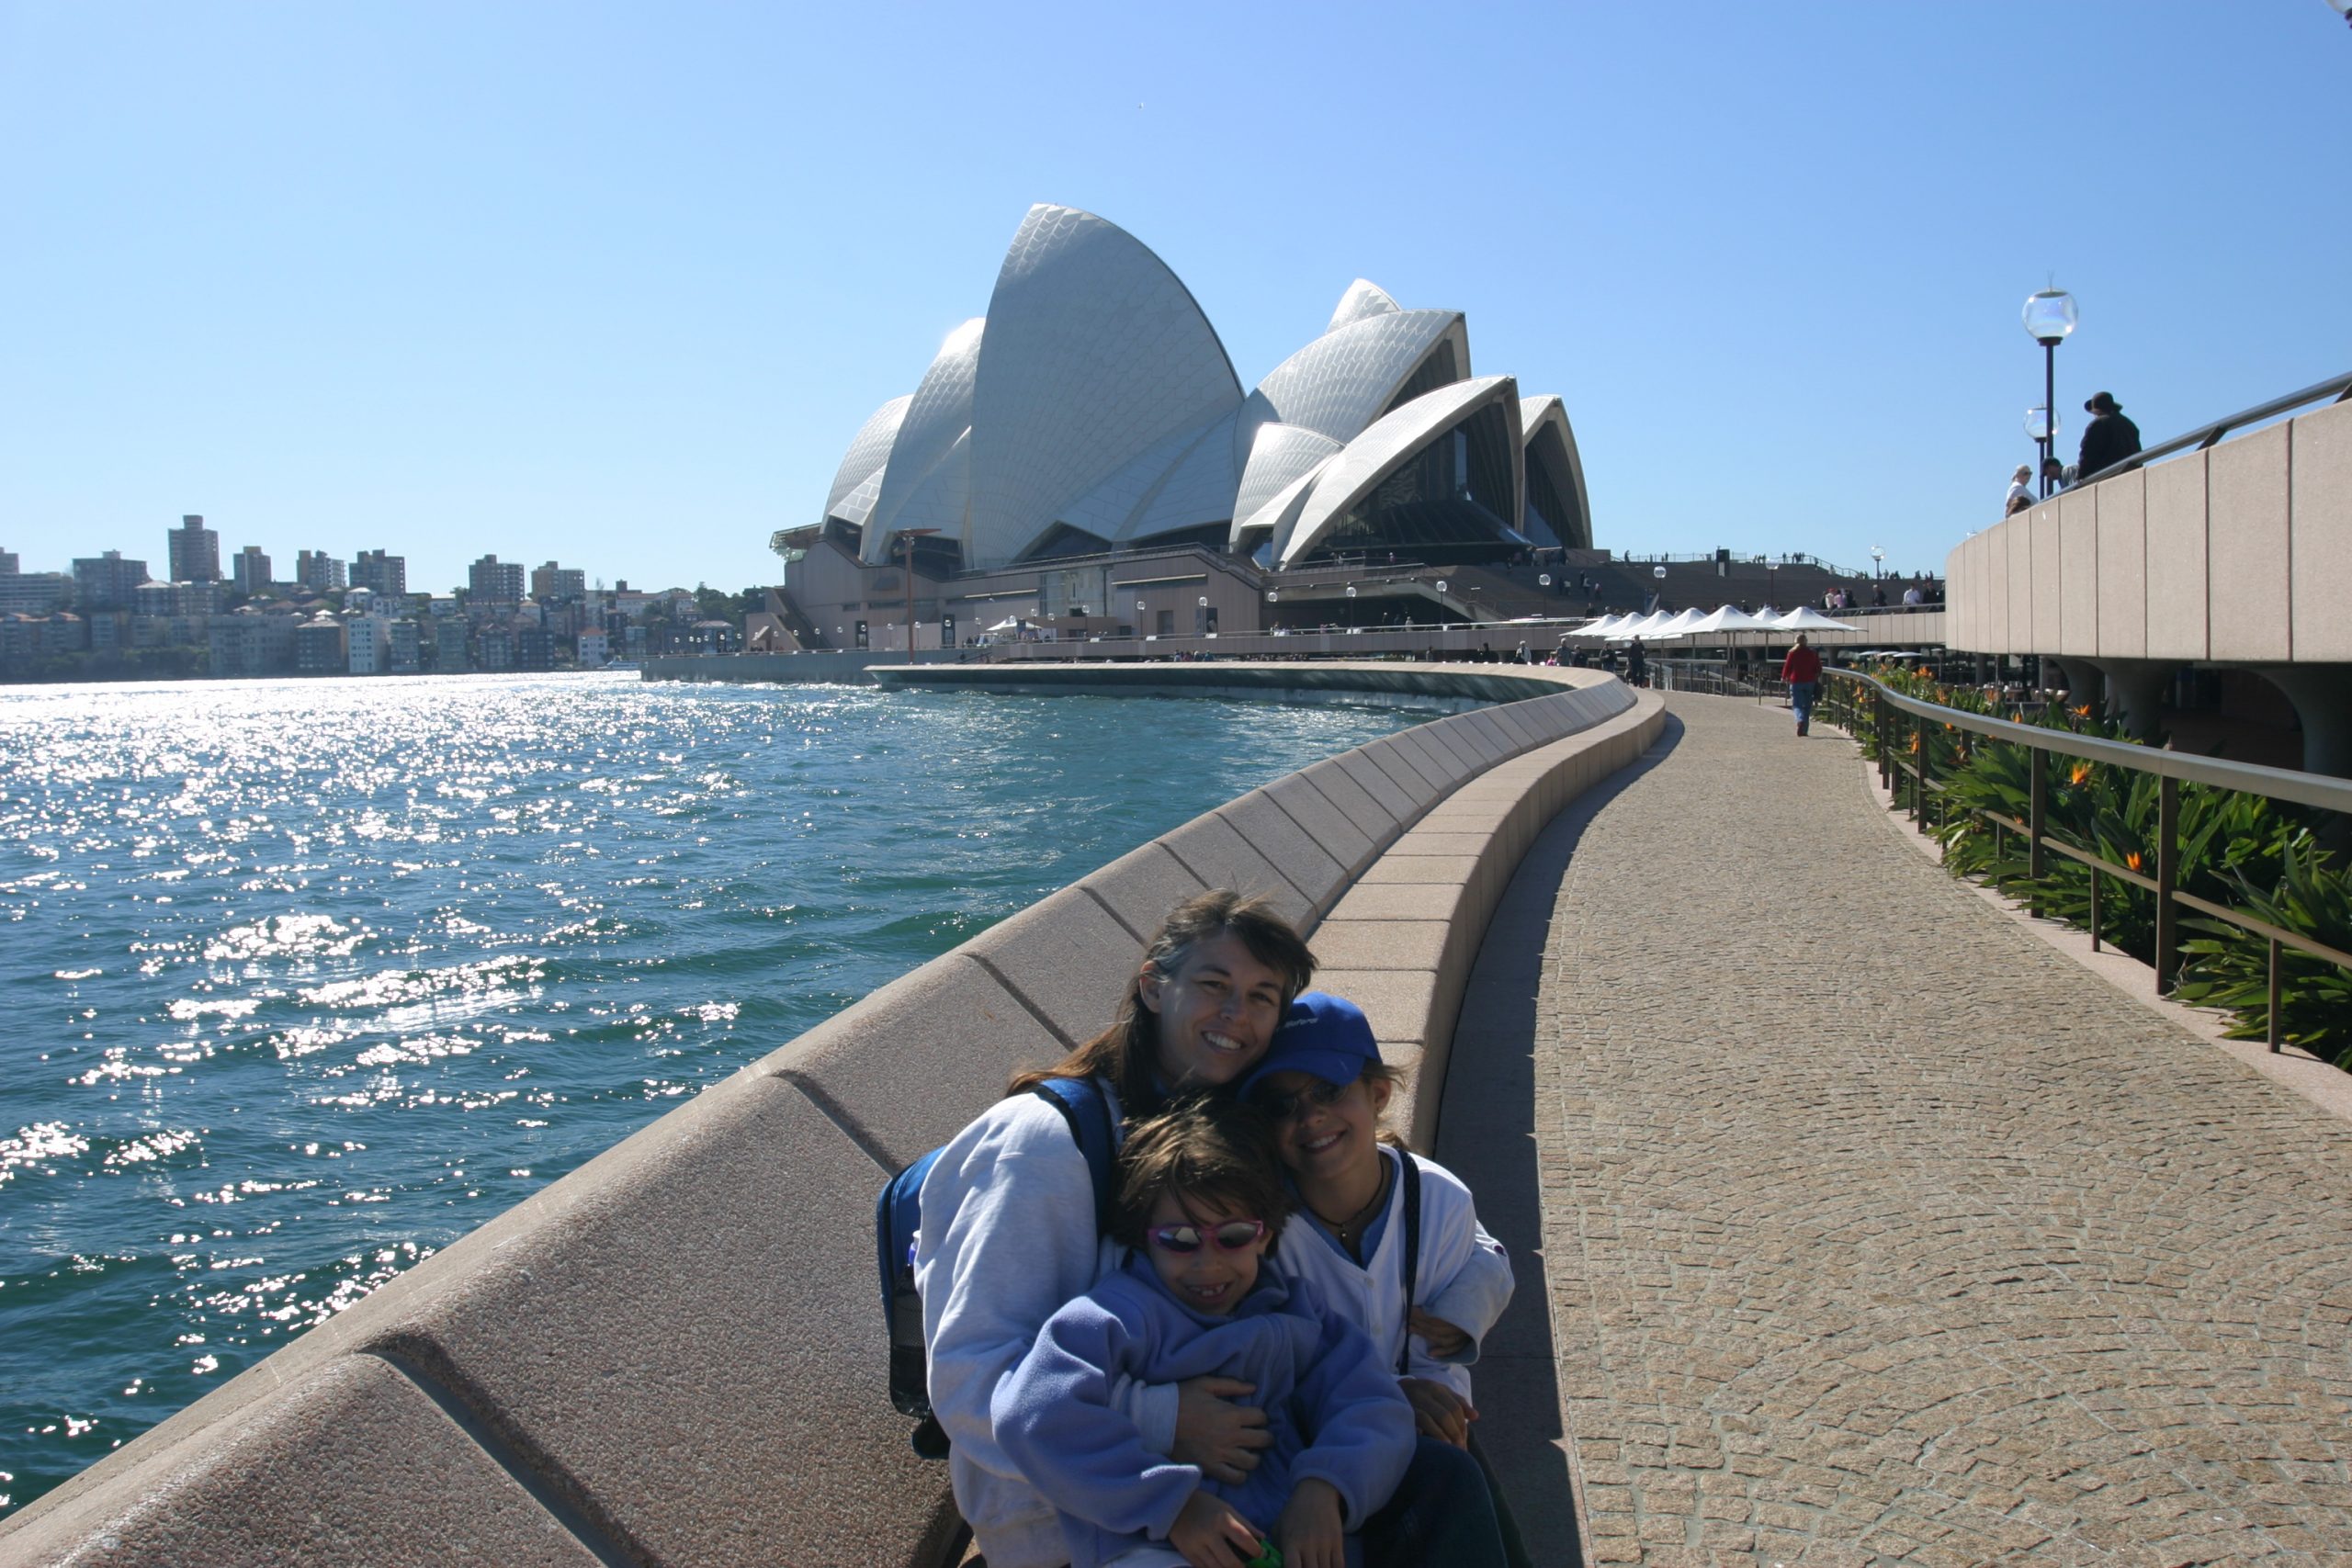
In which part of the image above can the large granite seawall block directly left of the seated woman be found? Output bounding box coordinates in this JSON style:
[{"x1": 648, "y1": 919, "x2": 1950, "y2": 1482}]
[{"x1": 355, "y1": 1075, "x2": 945, "y2": 1563}]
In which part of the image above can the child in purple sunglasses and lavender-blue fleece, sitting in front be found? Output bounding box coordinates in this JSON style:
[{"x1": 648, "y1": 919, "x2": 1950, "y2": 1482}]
[{"x1": 990, "y1": 1102, "x2": 1414, "y2": 1568}]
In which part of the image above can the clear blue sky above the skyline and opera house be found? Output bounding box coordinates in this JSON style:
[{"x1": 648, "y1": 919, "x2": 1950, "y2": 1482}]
[{"x1": 0, "y1": 0, "x2": 2352, "y2": 588}]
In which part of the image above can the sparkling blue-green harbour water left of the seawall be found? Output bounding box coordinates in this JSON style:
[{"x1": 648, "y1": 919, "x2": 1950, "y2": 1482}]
[{"x1": 0, "y1": 674, "x2": 1425, "y2": 1514}]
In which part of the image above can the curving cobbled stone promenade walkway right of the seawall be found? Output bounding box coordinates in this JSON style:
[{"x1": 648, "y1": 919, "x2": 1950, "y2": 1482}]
[{"x1": 1440, "y1": 696, "x2": 2352, "y2": 1568}]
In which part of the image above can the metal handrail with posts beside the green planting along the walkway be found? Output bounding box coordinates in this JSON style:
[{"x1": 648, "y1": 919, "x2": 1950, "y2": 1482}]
[{"x1": 1823, "y1": 668, "x2": 2352, "y2": 1051}]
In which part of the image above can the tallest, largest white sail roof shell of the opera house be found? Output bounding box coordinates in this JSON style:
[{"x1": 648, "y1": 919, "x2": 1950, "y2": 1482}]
[{"x1": 965, "y1": 202, "x2": 1242, "y2": 567}]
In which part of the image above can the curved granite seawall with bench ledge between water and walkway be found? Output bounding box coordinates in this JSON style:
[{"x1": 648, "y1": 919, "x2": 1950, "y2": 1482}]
[{"x1": 0, "y1": 665, "x2": 1663, "y2": 1568}]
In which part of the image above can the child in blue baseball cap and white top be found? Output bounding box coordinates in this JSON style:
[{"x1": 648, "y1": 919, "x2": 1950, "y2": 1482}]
[{"x1": 1242, "y1": 992, "x2": 1524, "y2": 1563}]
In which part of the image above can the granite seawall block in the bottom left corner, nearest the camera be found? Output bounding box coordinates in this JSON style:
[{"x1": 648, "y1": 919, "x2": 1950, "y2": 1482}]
[{"x1": 0, "y1": 1357, "x2": 605, "y2": 1568}]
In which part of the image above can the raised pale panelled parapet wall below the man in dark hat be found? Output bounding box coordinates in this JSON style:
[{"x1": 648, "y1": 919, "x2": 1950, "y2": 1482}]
[{"x1": 1945, "y1": 402, "x2": 2352, "y2": 665}]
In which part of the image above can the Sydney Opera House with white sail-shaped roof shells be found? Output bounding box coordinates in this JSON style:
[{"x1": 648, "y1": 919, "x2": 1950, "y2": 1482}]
[{"x1": 774, "y1": 205, "x2": 1592, "y2": 647}]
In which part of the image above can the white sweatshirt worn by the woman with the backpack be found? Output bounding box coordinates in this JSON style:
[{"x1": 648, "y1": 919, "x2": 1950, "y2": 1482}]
[{"x1": 915, "y1": 1079, "x2": 1176, "y2": 1568}]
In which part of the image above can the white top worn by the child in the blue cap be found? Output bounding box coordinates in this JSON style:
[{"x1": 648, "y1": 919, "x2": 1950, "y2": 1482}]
[{"x1": 1279, "y1": 1145, "x2": 1512, "y2": 1401}]
